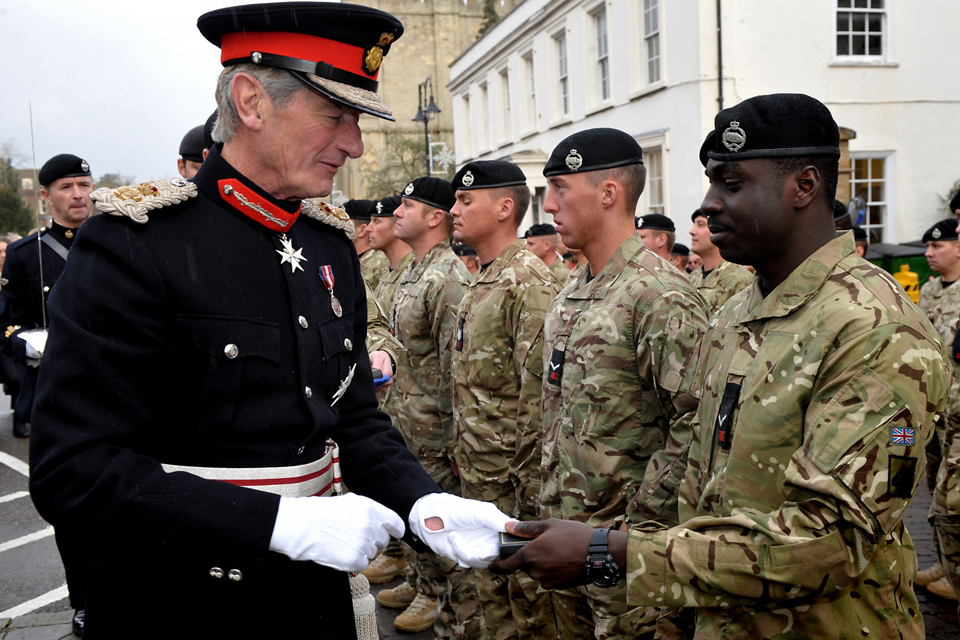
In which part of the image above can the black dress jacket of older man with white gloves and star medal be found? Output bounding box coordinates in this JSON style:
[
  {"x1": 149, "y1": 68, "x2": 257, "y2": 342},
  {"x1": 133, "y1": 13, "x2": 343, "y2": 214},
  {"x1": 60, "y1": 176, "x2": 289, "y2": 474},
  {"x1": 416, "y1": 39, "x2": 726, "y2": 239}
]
[{"x1": 30, "y1": 150, "x2": 439, "y2": 640}]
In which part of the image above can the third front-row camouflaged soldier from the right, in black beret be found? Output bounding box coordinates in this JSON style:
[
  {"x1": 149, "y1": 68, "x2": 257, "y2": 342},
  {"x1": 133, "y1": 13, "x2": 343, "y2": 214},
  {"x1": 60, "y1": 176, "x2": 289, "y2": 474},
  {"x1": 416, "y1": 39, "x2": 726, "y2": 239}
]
[{"x1": 451, "y1": 160, "x2": 563, "y2": 640}]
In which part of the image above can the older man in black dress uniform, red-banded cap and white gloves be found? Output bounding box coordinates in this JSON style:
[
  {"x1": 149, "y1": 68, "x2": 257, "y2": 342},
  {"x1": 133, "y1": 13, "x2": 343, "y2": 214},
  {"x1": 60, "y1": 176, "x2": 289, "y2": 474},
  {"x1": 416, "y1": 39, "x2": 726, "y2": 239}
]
[{"x1": 30, "y1": 2, "x2": 507, "y2": 639}]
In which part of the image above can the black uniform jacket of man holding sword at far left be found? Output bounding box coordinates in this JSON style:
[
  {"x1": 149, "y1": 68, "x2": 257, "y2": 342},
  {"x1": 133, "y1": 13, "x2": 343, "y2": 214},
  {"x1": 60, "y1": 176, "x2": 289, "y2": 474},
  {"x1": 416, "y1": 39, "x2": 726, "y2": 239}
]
[{"x1": 0, "y1": 223, "x2": 75, "y2": 422}]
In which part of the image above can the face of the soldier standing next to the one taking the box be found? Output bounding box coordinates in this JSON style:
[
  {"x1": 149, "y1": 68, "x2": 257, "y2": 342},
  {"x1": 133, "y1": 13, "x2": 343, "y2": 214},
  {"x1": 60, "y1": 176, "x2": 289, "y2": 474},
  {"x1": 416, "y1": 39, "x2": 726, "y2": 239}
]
[{"x1": 543, "y1": 173, "x2": 603, "y2": 249}]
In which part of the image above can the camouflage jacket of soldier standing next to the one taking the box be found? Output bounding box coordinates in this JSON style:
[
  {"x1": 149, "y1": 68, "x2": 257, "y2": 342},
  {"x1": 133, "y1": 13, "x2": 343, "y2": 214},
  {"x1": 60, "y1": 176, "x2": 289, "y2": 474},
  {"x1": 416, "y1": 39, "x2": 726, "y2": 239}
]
[{"x1": 540, "y1": 234, "x2": 706, "y2": 526}]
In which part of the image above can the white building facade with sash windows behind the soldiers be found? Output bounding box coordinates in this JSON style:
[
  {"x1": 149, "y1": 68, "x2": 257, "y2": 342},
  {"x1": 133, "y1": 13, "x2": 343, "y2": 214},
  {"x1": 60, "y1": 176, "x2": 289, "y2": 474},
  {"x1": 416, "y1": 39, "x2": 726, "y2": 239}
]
[{"x1": 448, "y1": 0, "x2": 960, "y2": 243}]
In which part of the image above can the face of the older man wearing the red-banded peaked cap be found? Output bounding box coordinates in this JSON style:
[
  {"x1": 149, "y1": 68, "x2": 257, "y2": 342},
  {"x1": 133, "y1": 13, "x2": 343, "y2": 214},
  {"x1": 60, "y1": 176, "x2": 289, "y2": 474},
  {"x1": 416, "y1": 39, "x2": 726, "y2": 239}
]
[{"x1": 256, "y1": 89, "x2": 363, "y2": 198}]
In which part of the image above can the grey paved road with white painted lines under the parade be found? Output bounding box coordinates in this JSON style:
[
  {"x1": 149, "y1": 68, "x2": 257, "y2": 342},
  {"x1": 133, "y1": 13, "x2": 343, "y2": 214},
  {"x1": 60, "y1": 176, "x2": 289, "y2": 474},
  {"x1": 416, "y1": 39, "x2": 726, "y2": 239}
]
[{"x1": 0, "y1": 382, "x2": 960, "y2": 640}]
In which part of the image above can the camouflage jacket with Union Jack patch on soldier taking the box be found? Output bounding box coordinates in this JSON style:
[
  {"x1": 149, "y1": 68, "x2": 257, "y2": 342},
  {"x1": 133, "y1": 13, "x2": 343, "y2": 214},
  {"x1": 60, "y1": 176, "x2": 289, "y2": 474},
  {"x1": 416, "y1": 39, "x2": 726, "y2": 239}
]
[{"x1": 627, "y1": 233, "x2": 947, "y2": 640}]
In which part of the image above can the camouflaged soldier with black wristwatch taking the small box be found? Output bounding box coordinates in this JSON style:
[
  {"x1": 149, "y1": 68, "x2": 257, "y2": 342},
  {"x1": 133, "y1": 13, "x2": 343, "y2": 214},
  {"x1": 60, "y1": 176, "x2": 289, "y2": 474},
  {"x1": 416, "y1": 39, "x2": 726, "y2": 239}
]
[{"x1": 491, "y1": 94, "x2": 948, "y2": 640}]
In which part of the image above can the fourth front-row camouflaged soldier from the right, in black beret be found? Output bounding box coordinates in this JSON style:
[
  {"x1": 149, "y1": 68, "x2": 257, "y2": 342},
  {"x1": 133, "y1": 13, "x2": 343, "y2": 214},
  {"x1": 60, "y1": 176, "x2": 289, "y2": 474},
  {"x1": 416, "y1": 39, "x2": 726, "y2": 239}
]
[{"x1": 390, "y1": 177, "x2": 478, "y2": 638}]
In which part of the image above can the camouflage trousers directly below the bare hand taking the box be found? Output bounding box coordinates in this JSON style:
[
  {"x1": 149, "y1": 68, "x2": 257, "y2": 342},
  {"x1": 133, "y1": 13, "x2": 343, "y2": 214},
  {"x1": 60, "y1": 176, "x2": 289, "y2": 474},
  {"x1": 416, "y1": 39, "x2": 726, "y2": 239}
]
[{"x1": 476, "y1": 570, "x2": 558, "y2": 640}]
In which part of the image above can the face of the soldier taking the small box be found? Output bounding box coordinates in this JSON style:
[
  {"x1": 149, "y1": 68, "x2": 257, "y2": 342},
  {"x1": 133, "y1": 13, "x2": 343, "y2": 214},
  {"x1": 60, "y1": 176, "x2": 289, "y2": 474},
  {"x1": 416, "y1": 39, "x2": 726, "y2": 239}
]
[{"x1": 694, "y1": 158, "x2": 788, "y2": 266}]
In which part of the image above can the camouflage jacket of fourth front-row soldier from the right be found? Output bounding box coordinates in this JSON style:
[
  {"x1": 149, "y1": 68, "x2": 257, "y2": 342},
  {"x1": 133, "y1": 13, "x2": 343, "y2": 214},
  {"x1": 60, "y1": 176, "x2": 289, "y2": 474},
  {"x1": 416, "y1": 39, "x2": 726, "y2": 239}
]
[{"x1": 390, "y1": 242, "x2": 470, "y2": 460}]
